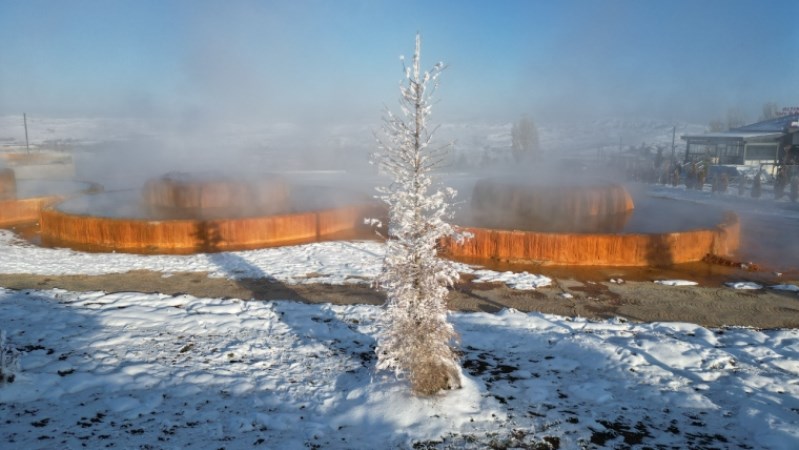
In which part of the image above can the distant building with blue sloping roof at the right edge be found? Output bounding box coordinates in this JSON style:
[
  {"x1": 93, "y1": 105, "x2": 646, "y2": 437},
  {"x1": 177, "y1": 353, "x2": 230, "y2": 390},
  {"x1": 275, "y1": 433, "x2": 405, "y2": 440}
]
[{"x1": 680, "y1": 108, "x2": 799, "y2": 165}]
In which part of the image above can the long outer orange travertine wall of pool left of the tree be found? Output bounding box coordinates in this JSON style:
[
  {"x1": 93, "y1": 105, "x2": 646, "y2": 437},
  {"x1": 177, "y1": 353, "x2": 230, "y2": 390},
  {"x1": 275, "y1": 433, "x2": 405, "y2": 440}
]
[{"x1": 41, "y1": 206, "x2": 380, "y2": 253}]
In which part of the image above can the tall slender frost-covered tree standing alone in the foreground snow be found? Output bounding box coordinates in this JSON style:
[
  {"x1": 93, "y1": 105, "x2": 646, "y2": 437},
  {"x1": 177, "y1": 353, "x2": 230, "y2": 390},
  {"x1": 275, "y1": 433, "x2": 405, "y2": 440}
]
[{"x1": 371, "y1": 34, "x2": 461, "y2": 395}]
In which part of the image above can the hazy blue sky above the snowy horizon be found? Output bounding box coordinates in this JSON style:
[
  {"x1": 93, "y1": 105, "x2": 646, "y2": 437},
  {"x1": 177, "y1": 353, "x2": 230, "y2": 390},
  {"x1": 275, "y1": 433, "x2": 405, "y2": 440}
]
[{"x1": 0, "y1": 0, "x2": 799, "y2": 123}]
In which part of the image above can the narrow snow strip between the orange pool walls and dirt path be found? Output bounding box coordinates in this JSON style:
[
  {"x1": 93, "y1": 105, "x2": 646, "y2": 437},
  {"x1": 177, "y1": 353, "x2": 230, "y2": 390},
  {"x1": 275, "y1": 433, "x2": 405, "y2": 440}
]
[{"x1": 0, "y1": 229, "x2": 552, "y2": 289}]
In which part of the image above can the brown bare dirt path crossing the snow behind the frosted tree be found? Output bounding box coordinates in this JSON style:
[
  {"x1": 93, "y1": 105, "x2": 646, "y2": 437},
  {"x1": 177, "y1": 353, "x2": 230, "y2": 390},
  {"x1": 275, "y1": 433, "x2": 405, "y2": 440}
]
[{"x1": 0, "y1": 271, "x2": 799, "y2": 328}]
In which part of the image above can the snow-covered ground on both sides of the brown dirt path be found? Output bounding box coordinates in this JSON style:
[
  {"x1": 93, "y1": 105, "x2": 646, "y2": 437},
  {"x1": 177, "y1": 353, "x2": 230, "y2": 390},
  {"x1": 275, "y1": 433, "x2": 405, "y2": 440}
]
[{"x1": 0, "y1": 231, "x2": 799, "y2": 449}]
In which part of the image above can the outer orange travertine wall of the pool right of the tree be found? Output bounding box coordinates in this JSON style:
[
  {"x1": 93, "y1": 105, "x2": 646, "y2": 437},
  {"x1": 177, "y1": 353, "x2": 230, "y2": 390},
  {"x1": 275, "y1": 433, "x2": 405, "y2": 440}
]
[{"x1": 442, "y1": 213, "x2": 740, "y2": 266}]
